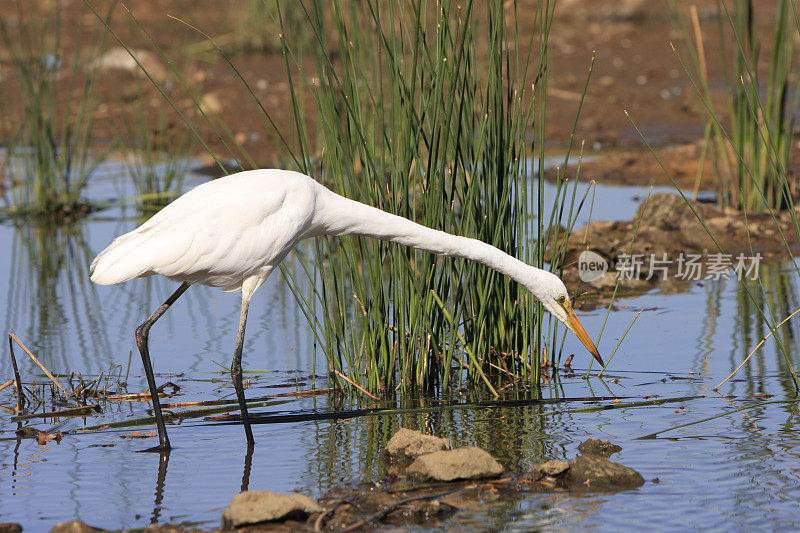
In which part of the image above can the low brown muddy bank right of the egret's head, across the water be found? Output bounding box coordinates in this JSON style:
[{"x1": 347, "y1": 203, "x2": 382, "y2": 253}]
[{"x1": 548, "y1": 193, "x2": 800, "y2": 300}]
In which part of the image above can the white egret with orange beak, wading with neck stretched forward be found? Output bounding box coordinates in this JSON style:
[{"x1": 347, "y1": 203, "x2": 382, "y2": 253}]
[{"x1": 90, "y1": 170, "x2": 602, "y2": 450}]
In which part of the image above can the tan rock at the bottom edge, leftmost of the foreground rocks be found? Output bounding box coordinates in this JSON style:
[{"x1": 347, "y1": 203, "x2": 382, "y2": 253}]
[{"x1": 222, "y1": 490, "x2": 322, "y2": 529}]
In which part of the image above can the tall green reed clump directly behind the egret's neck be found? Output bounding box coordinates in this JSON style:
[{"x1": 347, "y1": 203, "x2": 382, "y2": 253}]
[{"x1": 279, "y1": 0, "x2": 571, "y2": 392}]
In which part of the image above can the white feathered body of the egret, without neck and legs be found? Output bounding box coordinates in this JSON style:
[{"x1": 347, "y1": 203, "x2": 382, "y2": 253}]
[{"x1": 90, "y1": 170, "x2": 316, "y2": 291}]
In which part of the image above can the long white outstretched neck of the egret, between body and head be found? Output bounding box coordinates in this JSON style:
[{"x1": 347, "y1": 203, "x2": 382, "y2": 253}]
[{"x1": 314, "y1": 188, "x2": 555, "y2": 300}]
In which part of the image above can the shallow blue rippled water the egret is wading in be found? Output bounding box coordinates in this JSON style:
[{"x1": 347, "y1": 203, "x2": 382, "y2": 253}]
[{"x1": 0, "y1": 166, "x2": 800, "y2": 531}]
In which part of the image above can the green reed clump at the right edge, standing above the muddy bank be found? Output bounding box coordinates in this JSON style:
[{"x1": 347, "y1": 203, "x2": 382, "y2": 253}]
[{"x1": 672, "y1": 0, "x2": 800, "y2": 211}]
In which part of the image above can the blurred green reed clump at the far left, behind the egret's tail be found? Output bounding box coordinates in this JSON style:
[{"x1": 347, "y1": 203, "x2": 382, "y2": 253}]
[{"x1": 0, "y1": 1, "x2": 112, "y2": 215}]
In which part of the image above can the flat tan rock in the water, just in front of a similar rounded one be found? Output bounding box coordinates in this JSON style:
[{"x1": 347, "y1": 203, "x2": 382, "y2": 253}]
[{"x1": 407, "y1": 446, "x2": 503, "y2": 481}]
